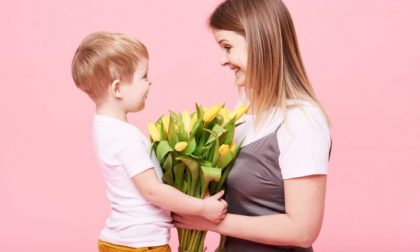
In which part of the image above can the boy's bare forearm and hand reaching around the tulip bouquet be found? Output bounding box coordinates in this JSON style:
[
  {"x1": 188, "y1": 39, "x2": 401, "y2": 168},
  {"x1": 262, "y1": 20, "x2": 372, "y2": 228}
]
[{"x1": 132, "y1": 167, "x2": 227, "y2": 222}]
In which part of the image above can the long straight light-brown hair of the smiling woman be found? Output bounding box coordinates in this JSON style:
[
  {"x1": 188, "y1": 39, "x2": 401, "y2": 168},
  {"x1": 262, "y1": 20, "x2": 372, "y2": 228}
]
[{"x1": 209, "y1": 0, "x2": 329, "y2": 124}]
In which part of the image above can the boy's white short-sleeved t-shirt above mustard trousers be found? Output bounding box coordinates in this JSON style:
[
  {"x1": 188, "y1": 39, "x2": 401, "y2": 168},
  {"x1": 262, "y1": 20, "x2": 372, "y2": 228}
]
[{"x1": 93, "y1": 115, "x2": 172, "y2": 248}]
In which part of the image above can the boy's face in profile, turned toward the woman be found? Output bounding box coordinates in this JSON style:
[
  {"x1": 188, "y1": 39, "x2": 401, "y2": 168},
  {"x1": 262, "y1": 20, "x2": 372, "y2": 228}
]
[{"x1": 123, "y1": 59, "x2": 152, "y2": 112}]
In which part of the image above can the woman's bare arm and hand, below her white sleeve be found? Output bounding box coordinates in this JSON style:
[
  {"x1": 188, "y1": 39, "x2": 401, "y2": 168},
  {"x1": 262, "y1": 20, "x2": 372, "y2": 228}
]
[{"x1": 174, "y1": 175, "x2": 326, "y2": 247}]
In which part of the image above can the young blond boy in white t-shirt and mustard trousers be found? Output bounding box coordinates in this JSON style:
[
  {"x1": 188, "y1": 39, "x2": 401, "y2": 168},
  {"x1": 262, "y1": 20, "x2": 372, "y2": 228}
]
[{"x1": 72, "y1": 32, "x2": 227, "y2": 252}]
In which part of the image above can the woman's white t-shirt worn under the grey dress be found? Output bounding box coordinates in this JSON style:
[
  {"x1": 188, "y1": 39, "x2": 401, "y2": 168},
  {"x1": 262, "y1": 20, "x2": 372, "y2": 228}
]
[{"x1": 235, "y1": 100, "x2": 331, "y2": 179}]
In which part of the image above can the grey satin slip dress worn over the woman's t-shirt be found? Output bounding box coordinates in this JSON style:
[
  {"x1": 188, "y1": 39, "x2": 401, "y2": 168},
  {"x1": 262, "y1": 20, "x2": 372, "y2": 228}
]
[{"x1": 224, "y1": 125, "x2": 313, "y2": 252}]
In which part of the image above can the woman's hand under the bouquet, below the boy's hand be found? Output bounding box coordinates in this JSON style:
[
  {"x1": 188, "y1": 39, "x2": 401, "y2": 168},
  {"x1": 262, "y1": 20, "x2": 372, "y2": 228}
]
[{"x1": 172, "y1": 213, "x2": 218, "y2": 232}]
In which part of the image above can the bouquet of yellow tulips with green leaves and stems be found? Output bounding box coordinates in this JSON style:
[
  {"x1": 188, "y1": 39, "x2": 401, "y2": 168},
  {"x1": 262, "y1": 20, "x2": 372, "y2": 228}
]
[{"x1": 147, "y1": 104, "x2": 248, "y2": 252}]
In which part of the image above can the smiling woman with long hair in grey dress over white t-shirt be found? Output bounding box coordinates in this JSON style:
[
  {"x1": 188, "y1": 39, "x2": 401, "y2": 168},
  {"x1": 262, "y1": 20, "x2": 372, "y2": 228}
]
[{"x1": 174, "y1": 0, "x2": 331, "y2": 252}]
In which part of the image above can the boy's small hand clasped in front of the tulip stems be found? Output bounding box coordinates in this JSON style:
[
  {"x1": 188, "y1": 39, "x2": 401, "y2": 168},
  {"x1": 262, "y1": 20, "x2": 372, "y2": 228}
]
[{"x1": 201, "y1": 191, "x2": 227, "y2": 223}]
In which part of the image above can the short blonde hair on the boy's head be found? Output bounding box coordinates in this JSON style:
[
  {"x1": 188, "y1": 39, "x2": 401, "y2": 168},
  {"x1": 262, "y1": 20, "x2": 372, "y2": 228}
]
[{"x1": 71, "y1": 32, "x2": 149, "y2": 103}]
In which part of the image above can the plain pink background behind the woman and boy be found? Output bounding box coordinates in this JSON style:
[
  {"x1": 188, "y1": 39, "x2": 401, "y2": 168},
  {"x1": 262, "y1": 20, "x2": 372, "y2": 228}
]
[{"x1": 0, "y1": 0, "x2": 420, "y2": 252}]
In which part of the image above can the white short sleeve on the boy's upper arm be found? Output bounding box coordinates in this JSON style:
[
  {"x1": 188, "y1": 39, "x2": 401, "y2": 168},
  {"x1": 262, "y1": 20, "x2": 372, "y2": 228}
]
[{"x1": 118, "y1": 130, "x2": 153, "y2": 178}]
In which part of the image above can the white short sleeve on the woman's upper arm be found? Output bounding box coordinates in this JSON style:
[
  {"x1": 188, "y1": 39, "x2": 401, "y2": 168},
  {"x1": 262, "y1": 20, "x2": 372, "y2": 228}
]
[{"x1": 277, "y1": 106, "x2": 331, "y2": 179}]
